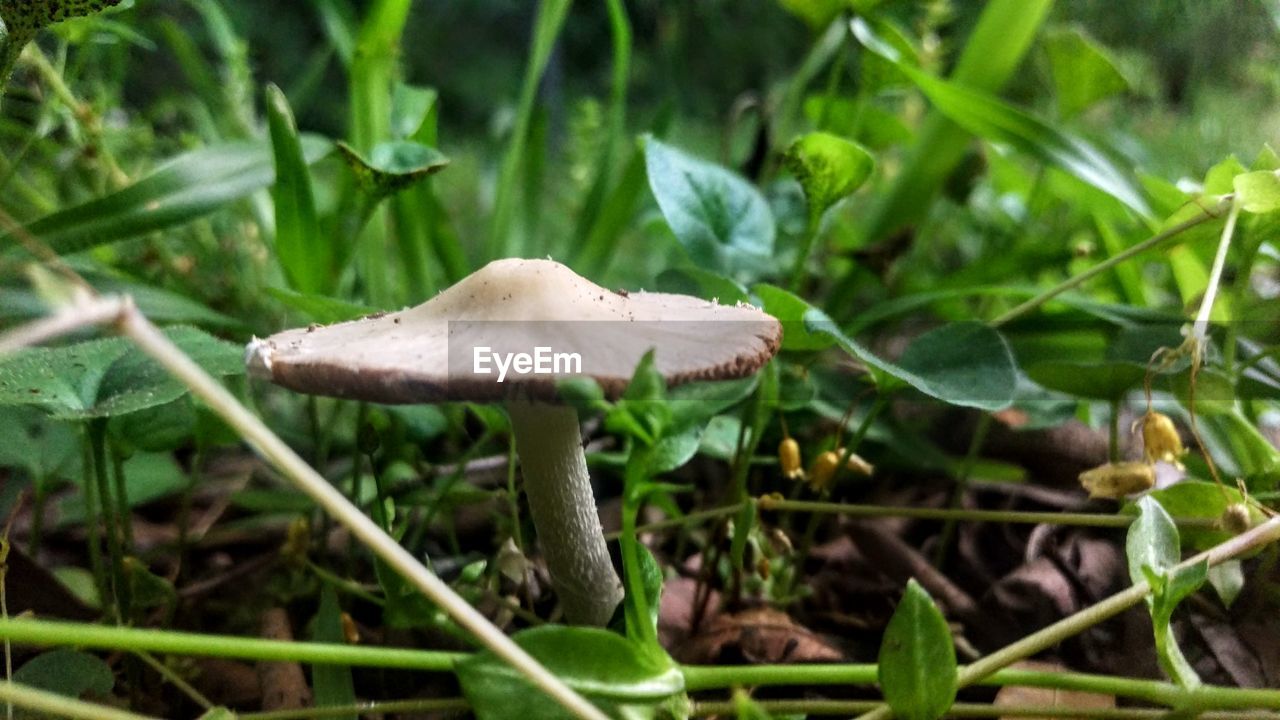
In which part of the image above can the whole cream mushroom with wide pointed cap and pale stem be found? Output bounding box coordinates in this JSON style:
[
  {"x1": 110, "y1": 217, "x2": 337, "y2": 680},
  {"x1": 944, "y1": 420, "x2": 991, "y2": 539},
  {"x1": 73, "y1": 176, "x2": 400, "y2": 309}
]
[{"x1": 246, "y1": 260, "x2": 782, "y2": 625}]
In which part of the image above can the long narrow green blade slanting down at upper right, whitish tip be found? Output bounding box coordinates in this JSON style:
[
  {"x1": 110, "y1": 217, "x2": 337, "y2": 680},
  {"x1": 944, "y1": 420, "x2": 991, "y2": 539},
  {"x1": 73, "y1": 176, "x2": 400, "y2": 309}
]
[{"x1": 852, "y1": 18, "x2": 1151, "y2": 217}]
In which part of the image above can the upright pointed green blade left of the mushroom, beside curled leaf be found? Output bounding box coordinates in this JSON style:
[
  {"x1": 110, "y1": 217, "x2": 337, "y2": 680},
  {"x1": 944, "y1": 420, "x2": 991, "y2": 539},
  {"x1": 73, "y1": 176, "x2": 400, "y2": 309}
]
[{"x1": 266, "y1": 85, "x2": 325, "y2": 293}]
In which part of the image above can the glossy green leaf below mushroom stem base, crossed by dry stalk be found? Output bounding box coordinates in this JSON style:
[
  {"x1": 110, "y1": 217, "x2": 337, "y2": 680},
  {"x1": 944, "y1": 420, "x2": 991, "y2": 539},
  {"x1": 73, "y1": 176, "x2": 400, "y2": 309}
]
[{"x1": 454, "y1": 625, "x2": 685, "y2": 720}]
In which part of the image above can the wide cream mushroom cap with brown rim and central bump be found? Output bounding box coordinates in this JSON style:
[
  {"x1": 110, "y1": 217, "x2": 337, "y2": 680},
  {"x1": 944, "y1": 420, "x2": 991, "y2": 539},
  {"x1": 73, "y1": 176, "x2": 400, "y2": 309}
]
[{"x1": 246, "y1": 260, "x2": 782, "y2": 404}]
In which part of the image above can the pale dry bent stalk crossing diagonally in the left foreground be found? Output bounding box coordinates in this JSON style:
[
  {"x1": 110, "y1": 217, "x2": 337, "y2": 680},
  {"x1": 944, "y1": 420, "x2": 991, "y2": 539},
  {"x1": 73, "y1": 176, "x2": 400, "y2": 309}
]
[{"x1": 0, "y1": 296, "x2": 608, "y2": 720}]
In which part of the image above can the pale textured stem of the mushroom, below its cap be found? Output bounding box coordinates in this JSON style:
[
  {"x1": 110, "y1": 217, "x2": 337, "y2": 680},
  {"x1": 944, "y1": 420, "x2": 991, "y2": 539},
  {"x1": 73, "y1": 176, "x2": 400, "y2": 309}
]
[{"x1": 507, "y1": 400, "x2": 622, "y2": 628}]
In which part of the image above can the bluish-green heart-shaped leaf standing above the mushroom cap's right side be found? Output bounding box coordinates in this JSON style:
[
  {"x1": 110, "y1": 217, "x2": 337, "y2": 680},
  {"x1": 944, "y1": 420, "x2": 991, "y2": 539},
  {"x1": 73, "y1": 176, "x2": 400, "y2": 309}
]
[{"x1": 645, "y1": 137, "x2": 776, "y2": 277}]
